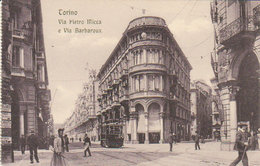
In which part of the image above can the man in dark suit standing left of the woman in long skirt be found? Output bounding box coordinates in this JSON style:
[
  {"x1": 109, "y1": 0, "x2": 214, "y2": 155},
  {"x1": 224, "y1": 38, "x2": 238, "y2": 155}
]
[{"x1": 27, "y1": 130, "x2": 39, "y2": 164}]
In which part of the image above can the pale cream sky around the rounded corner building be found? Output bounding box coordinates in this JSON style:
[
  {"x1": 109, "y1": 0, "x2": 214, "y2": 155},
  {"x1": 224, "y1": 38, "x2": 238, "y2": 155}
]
[{"x1": 41, "y1": 0, "x2": 214, "y2": 123}]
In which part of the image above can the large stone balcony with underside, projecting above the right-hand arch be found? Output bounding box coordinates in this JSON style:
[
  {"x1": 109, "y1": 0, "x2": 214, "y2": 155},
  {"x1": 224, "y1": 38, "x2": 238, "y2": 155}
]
[{"x1": 219, "y1": 16, "x2": 255, "y2": 45}]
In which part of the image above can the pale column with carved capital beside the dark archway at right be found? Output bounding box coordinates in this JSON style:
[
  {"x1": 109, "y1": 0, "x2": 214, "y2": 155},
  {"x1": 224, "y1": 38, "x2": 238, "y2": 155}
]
[{"x1": 229, "y1": 86, "x2": 239, "y2": 144}]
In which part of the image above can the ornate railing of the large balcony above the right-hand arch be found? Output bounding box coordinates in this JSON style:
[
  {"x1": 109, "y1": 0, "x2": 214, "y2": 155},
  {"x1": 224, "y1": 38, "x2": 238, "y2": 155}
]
[{"x1": 219, "y1": 16, "x2": 255, "y2": 44}]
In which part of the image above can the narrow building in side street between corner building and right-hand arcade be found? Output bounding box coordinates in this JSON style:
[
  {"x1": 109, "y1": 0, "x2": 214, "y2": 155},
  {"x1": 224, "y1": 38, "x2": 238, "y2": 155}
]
[{"x1": 190, "y1": 80, "x2": 212, "y2": 138}]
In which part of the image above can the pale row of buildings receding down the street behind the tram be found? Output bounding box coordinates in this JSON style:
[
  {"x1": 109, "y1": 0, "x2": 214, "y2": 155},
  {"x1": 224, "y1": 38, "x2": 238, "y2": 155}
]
[{"x1": 64, "y1": 71, "x2": 99, "y2": 141}]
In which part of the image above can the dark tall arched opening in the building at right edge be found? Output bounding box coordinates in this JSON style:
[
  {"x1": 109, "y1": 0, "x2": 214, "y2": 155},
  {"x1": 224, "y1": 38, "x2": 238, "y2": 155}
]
[{"x1": 236, "y1": 54, "x2": 260, "y2": 131}]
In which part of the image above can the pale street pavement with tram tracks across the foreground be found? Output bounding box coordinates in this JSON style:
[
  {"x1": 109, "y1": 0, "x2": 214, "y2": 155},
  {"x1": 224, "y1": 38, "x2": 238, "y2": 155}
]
[{"x1": 3, "y1": 142, "x2": 260, "y2": 166}]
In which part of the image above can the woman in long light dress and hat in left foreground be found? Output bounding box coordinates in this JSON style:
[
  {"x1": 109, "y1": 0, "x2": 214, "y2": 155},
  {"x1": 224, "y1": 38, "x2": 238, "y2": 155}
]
[{"x1": 50, "y1": 129, "x2": 68, "y2": 166}]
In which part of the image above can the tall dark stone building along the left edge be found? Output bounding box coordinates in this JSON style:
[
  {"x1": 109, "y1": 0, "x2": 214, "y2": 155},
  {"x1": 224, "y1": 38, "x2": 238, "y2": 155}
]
[{"x1": 2, "y1": 0, "x2": 51, "y2": 148}]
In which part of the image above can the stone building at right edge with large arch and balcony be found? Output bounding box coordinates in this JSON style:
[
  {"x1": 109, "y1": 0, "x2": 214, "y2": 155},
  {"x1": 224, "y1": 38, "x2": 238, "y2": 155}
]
[{"x1": 211, "y1": 0, "x2": 260, "y2": 150}]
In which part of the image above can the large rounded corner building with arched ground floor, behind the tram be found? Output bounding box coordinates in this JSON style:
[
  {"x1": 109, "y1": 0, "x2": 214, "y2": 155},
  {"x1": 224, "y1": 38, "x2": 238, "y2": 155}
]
[{"x1": 98, "y1": 17, "x2": 192, "y2": 143}]
